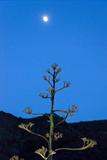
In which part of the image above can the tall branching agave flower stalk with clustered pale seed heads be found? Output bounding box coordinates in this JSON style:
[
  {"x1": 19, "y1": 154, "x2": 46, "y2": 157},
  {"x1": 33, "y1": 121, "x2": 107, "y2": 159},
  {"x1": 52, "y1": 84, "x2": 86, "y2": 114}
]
[{"x1": 19, "y1": 64, "x2": 96, "y2": 160}]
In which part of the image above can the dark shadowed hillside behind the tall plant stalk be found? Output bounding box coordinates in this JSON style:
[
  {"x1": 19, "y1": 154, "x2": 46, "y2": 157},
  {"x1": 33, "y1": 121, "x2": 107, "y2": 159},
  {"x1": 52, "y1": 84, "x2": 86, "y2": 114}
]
[{"x1": 0, "y1": 111, "x2": 107, "y2": 160}]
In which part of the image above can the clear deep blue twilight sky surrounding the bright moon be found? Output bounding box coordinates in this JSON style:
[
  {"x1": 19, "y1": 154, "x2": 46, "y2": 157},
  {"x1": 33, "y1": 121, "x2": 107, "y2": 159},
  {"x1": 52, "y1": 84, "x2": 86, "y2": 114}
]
[{"x1": 0, "y1": 0, "x2": 107, "y2": 121}]
